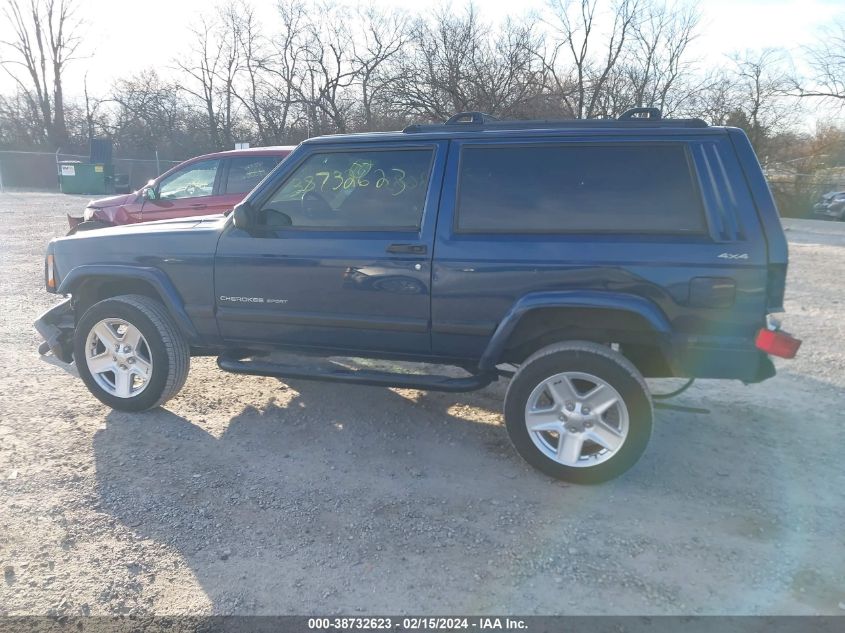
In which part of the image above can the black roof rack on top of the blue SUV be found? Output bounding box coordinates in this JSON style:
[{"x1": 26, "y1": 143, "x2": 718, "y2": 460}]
[{"x1": 402, "y1": 108, "x2": 709, "y2": 134}]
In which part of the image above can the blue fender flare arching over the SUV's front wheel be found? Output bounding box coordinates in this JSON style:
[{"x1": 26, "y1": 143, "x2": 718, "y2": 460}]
[{"x1": 56, "y1": 264, "x2": 199, "y2": 341}]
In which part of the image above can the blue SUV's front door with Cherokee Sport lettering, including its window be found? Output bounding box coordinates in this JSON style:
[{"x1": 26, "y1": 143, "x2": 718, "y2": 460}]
[{"x1": 214, "y1": 142, "x2": 447, "y2": 354}]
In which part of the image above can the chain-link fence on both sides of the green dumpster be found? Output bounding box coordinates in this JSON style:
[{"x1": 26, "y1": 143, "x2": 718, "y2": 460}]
[{"x1": 0, "y1": 150, "x2": 181, "y2": 191}]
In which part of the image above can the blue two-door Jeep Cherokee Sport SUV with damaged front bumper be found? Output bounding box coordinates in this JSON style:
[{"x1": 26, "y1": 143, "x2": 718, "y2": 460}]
[{"x1": 36, "y1": 109, "x2": 799, "y2": 483}]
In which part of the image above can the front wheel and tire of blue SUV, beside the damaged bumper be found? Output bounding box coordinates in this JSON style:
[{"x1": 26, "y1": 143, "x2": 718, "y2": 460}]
[{"x1": 73, "y1": 295, "x2": 190, "y2": 411}]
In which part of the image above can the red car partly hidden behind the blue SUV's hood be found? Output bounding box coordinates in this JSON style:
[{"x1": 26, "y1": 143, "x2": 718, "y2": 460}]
[{"x1": 68, "y1": 146, "x2": 293, "y2": 233}]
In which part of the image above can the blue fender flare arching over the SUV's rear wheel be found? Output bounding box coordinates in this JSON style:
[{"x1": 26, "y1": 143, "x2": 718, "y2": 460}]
[{"x1": 478, "y1": 290, "x2": 672, "y2": 371}]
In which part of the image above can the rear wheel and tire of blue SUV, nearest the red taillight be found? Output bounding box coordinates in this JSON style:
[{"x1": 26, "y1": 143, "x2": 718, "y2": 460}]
[{"x1": 505, "y1": 341, "x2": 653, "y2": 484}]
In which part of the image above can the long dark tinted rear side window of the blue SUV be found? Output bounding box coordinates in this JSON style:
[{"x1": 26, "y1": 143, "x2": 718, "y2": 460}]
[{"x1": 457, "y1": 144, "x2": 705, "y2": 233}]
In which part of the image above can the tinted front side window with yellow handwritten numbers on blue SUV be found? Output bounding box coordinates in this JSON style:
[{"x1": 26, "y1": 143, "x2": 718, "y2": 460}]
[{"x1": 259, "y1": 149, "x2": 434, "y2": 230}]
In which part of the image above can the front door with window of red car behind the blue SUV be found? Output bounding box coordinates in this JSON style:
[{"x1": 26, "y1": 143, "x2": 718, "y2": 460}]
[{"x1": 141, "y1": 158, "x2": 226, "y2": 222}]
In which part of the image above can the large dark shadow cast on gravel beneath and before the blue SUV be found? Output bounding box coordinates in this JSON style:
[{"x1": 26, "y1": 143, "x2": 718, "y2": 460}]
[{"x1": 89, "y1": 378, "x2": 845, "y2": 614}]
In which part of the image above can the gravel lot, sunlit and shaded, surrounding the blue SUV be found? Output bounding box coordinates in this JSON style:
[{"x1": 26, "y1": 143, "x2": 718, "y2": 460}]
[{"x1": 0, "y1": 194, "x2": 845, "y2": 614}]
